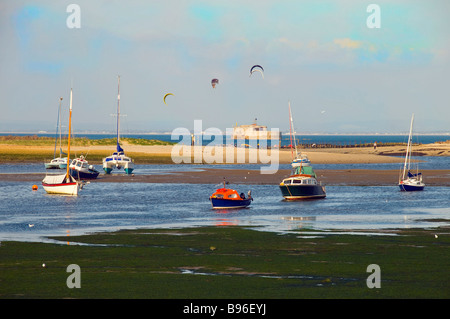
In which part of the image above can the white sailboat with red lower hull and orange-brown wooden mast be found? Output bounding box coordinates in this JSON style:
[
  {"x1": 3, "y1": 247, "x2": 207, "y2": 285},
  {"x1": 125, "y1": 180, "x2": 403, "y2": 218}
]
[{"x1": 42, "y1": 89, "x2": 83, "y2": 196}]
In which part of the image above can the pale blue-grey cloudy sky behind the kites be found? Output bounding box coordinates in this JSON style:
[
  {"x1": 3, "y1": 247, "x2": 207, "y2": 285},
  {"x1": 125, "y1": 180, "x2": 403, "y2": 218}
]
[{"x1": 0, "y1": 0, "x2": 450, "y2": 134}]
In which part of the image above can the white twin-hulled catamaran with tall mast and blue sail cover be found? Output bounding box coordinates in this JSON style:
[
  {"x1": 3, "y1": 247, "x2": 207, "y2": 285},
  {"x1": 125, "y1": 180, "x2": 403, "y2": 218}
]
[{"x1": 103, "y1": 76, "x2": 134, "y2": 174}]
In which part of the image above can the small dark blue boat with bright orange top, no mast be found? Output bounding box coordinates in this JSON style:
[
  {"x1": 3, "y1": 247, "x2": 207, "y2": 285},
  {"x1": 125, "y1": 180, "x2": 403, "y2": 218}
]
[{"x1": 209, "y1": 181, "x2": 253, "y2": 209}]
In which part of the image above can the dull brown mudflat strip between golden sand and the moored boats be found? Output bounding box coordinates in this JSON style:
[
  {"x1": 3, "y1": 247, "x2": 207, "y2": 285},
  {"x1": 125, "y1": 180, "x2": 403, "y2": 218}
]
[{"x1": 0, "y1": 167, "x2": 450, "y2": 188}]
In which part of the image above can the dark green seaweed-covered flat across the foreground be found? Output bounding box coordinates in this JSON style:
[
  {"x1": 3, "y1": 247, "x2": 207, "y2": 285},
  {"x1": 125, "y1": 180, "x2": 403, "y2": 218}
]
[{"x1": 0, "y1": 226, "x2": 450, "y2": 299}]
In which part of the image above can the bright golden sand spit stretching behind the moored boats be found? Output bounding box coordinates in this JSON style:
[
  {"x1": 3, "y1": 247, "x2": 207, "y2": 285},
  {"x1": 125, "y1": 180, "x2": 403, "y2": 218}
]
[{"x1": 0, "y1": 142, "x2": 450, "y2": 165}]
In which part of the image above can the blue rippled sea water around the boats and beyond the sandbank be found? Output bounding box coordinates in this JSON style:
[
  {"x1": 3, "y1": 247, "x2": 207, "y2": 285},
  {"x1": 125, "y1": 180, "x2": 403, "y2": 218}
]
[{"x1": 0, "y1": 134, "x2": 450, "y2": 244}]
